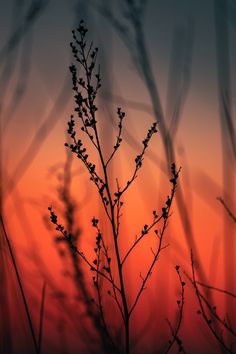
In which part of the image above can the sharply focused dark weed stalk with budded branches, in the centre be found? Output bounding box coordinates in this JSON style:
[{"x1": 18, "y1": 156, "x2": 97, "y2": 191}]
[{"x1": 49, "y1": 21, "x2": 180, "y2": 354}]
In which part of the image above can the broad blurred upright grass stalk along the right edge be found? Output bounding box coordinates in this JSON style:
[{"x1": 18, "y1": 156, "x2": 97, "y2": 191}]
[{"x1": 214, "y1": 0, "x2": 236, "y2": 324}]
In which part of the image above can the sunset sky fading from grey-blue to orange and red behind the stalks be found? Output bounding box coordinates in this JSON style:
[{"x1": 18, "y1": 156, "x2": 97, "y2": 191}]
[{"x1": 0, "y1": 0, "x2": 236, "y2": 353}]
